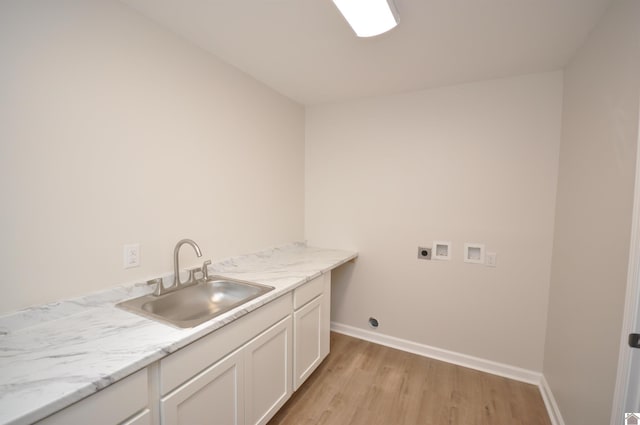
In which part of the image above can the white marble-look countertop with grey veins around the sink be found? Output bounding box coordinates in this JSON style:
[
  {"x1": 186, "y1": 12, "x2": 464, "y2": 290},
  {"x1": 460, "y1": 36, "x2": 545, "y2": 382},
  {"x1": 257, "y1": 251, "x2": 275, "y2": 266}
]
[{"x1": 0, "y1": 243, "x2": 357, "y2": 425}]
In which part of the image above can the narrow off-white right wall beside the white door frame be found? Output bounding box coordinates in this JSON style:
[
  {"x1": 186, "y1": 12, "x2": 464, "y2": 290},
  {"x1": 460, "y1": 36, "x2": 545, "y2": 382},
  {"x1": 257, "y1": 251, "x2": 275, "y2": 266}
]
[{"x1": 544, "y1": 0, "x2": 640, "y2": 425}]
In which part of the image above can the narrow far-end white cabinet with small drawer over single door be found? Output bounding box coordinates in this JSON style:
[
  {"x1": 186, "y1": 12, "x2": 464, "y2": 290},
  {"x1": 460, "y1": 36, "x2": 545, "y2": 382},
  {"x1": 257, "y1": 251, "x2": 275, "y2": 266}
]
[{"x1": 293, "y1": 273, "x2": 331, "y2": 390}]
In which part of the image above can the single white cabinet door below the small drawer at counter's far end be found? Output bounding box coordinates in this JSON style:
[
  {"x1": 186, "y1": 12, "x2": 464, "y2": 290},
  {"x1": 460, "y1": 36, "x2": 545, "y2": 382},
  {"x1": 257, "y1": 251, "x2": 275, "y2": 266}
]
[{"x1": 293, "y1": 295, "x2": 325, "y2": 390}]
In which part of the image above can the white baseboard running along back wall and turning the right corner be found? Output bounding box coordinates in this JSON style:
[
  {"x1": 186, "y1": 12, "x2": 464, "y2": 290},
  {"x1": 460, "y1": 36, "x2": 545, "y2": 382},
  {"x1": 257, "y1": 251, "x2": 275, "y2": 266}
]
[{"x1": 331, "y1": 322, "x2": 565, "y2": 425}]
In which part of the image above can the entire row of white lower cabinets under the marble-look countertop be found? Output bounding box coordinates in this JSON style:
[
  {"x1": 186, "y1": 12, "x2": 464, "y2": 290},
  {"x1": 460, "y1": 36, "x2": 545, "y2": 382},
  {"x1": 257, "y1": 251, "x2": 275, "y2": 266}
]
[{"x1": 38, "y1": 273, "x2": 331, "y2": 425}]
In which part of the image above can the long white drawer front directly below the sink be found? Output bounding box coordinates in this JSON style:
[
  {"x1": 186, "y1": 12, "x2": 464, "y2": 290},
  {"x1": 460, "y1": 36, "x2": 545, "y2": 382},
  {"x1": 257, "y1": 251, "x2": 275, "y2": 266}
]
[{"x1": 160, "y1": 293, "x2": 291, "y2": 395}]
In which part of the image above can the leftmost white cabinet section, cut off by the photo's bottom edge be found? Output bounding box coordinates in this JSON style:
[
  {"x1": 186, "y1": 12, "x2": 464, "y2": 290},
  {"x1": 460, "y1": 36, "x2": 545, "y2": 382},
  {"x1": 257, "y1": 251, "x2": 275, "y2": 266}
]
[{"x1": 37, "y1": 369, "x2": 151, "y2": 425}]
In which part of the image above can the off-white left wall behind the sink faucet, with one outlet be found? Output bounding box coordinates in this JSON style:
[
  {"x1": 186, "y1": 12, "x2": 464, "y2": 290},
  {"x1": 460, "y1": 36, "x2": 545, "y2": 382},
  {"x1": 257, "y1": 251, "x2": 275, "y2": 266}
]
[{"x1": 0, "y1": 0, "x2": 304, "y2": 312}]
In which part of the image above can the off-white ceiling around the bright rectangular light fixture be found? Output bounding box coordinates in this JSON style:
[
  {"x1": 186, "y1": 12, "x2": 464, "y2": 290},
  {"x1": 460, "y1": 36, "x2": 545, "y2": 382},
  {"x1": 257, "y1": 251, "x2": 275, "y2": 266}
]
[{"x1": 122, "y1": 0, "x2": 612, "y2": 104}]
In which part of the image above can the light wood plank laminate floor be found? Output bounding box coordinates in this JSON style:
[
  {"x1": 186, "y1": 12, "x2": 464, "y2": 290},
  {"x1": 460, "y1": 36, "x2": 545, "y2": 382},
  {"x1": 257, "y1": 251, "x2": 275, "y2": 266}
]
[{"x1": 269, "y1": 332, "x2": 551, "y2": 425}]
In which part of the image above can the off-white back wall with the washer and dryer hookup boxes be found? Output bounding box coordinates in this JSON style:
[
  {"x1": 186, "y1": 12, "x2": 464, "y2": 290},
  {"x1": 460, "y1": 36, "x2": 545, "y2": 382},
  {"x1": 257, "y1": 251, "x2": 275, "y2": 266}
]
[{"x1": 305, "y1": 72, "x2": 562, "y2": 371}]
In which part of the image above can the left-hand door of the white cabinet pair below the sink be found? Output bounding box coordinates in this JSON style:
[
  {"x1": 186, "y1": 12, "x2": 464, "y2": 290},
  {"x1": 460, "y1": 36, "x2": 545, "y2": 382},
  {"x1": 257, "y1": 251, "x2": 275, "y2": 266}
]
[{"x1": 160, "y1": 350, "x2": 244, "y2": 425}]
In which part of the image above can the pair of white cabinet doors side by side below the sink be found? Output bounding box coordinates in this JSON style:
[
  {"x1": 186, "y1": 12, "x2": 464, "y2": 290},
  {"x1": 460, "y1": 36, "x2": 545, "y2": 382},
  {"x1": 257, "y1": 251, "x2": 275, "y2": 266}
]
[{"x1": 160, "y1": 316, "x2": 292, "y2": 425}]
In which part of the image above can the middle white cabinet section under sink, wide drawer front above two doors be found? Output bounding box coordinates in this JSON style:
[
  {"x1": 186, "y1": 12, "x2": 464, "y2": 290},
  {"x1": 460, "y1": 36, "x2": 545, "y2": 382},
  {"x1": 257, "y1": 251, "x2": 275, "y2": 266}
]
[{"x1": 160, "y1": 294, "x2": 293, "y2": 425}]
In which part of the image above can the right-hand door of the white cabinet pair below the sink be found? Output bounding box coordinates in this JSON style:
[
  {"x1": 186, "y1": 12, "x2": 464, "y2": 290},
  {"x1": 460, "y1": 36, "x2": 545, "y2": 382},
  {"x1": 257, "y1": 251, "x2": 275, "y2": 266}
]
[{"x1": 244, "y1": 316, "x2": 293, "y2": 425}]
